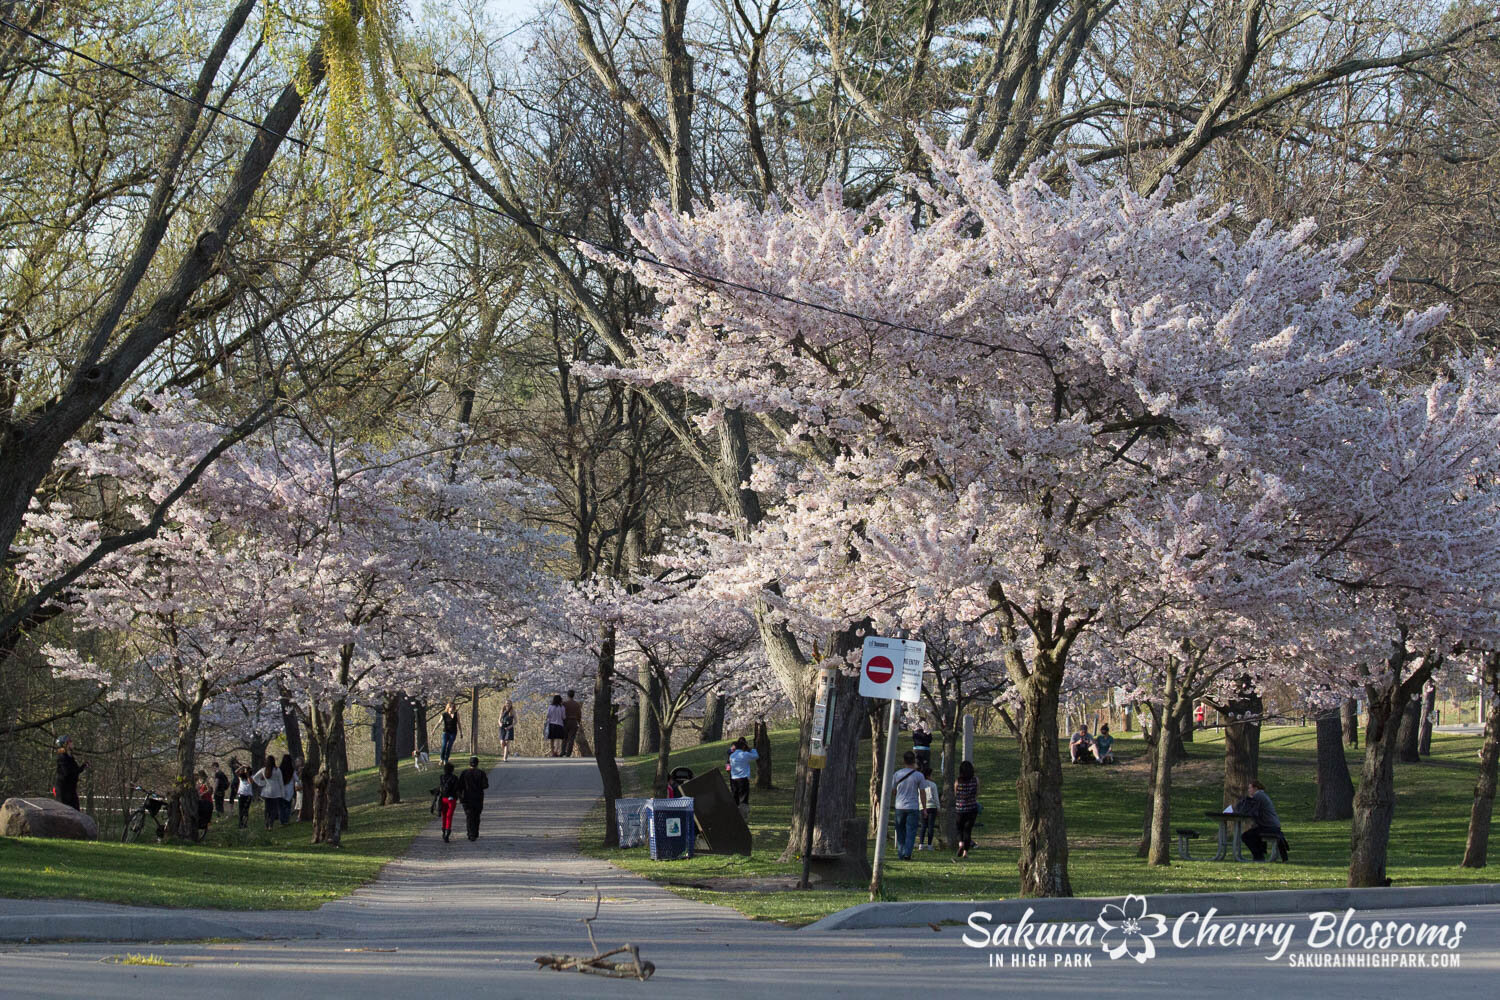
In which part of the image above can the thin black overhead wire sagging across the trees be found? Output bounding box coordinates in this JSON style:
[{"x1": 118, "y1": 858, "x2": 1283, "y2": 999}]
[{"x1": 0, "y1": 16, "x2": 1031, "y2": 354}]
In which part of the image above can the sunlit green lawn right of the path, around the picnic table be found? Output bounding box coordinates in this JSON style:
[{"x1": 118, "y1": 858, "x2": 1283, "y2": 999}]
[{"x1": 584, "y1": 727, "x2": 1500, "y2": 924}]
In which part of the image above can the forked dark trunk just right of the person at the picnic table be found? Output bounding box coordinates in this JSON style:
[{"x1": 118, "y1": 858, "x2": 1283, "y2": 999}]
[{"x1": 1349, "y1": 650, "x2": 1437, "y2": 889}]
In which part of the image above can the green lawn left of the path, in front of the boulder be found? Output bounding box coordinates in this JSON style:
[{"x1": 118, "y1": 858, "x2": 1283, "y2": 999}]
[{"x1": 0, "y1": 762, "x2": 468, "y2": 910}]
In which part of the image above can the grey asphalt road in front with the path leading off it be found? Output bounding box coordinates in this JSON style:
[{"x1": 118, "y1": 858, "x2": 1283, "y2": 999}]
[{"x1": 0, "y1": 760, "x2": 1500, "y2": 1000}]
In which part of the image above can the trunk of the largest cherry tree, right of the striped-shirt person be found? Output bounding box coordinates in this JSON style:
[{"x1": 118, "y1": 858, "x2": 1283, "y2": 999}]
[{"x1": 1013, "y1": 651, "x2": 1073, "y2": 897}]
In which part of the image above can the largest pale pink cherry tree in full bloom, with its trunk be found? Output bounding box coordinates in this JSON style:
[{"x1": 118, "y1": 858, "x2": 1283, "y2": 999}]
[{"x1": 591, "y1": 137, "x2": 1496, "y2": 895}]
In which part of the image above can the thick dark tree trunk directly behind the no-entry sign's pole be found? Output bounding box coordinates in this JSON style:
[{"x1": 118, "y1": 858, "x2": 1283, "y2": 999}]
[{"x1": 782, "y1": 673, "x2": 866, "y2": 861}]
